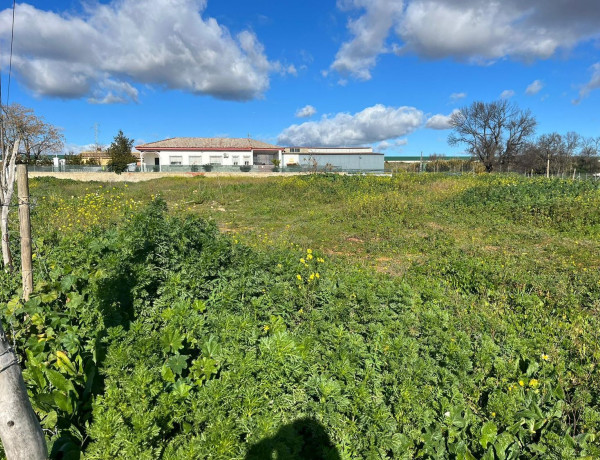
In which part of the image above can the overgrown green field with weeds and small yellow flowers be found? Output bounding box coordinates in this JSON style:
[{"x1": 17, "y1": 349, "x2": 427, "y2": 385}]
[{"x1": 0, "y1": 174, "x2": 600, "y2": 459}]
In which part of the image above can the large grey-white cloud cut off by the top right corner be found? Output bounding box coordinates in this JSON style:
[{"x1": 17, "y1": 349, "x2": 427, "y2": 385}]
[{"x1": 331, "y1": 0, "x2": 600, "y2": 80}]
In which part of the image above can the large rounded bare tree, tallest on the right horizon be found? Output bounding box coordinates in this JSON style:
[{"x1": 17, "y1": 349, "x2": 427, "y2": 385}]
[{"x1": 448, "y1": 100, "x2": 537, "y2": 172}]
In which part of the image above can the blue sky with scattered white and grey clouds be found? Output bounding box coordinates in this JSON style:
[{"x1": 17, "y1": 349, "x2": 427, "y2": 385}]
[{"x1": 0, "y1": 0, "x2": 600, "y2": 155}]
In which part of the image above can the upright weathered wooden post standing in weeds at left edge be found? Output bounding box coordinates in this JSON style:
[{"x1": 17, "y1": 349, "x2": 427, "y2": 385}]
[{"x1": 17, "y1": 165, "x2": 33, "y2": 301}]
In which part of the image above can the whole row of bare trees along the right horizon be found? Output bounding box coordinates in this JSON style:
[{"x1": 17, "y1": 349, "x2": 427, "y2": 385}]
[{"x1": 448, "y1": 100, "x2": 600, "y2": 175}]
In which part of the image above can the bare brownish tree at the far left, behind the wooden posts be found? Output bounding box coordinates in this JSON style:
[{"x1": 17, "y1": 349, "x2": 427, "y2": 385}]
[{"x1": 2, "y1": 104, "x2": 64, "y2": 163}]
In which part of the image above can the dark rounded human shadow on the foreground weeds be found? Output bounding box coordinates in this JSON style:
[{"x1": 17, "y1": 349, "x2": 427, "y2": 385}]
[{"x1": 246, "y1": 418, "x2": 341, "y2": 460}]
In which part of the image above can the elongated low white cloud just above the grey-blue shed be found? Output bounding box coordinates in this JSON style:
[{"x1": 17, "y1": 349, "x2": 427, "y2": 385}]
[{"x1": 277, "y1": 104, "x2": 423, "y2": 147}]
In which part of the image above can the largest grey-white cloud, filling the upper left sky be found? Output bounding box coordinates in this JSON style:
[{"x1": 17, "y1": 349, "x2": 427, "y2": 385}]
[{"x1": 0, "y1": 0, "x2": 278, "y2": 103}]
